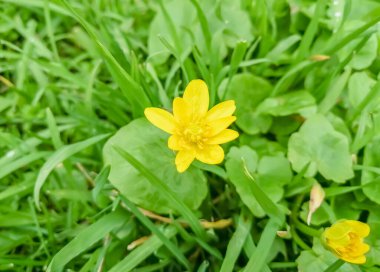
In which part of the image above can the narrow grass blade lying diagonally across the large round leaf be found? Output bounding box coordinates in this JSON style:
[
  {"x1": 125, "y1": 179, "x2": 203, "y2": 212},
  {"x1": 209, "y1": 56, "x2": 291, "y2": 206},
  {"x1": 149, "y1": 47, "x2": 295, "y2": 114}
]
[{"x1": 114, "y1": 146, "x2": 207, "y2": 240}]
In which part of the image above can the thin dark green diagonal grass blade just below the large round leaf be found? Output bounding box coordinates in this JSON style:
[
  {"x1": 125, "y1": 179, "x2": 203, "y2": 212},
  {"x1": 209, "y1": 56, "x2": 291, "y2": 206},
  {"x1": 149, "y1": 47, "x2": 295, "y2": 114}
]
[{"x1": 119, "y1": 195, "x2": 190, "y2": 270}]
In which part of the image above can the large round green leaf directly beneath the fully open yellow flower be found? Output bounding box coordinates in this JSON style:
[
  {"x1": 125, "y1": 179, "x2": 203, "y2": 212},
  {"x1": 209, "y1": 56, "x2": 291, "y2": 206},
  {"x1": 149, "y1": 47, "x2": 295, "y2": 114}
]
[{"x1": 103, "y1": 119, "x2": 207, "y2": 213}]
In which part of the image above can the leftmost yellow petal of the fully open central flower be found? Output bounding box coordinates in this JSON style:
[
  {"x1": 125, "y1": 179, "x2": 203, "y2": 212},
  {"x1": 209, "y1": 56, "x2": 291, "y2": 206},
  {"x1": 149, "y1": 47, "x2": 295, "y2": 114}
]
[{"x1": 144, "y1": 108, "x2": 176, "y2": 134}]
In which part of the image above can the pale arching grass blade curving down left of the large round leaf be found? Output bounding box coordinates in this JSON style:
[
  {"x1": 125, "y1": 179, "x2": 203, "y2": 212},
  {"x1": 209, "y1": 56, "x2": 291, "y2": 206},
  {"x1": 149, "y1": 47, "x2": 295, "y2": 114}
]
[{"x1": 33, "y1": 134, "x2": 110, "y2": 210}]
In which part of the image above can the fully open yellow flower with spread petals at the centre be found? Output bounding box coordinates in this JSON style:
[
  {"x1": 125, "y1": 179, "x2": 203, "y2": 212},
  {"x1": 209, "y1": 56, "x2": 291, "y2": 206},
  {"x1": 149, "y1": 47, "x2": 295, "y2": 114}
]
[{"x1": 144, "y1": 79, "x2": 239, "y2": 173}]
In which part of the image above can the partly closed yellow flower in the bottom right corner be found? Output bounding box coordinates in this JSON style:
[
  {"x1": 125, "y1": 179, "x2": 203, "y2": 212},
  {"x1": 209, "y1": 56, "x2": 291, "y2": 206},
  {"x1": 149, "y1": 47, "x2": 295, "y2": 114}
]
[{"x1": 323, "y1": 220, "x2": 370, "y2": 264}]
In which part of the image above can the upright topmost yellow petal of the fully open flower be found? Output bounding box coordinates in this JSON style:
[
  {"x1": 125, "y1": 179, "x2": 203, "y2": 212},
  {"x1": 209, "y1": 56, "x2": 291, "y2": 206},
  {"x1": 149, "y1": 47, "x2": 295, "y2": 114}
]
[{"x1": 183, "y1": 79, "x2": 209, "y2": 116}]
